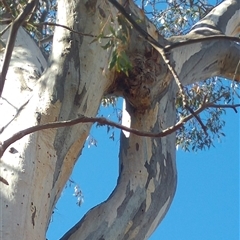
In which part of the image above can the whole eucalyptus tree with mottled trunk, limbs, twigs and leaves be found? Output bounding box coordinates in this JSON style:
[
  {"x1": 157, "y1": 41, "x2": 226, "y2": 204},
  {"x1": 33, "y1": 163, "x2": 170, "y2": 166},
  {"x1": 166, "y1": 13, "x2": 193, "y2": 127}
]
[{"x1": 0, "y1": 0, "x2": 240, "y2": 239}]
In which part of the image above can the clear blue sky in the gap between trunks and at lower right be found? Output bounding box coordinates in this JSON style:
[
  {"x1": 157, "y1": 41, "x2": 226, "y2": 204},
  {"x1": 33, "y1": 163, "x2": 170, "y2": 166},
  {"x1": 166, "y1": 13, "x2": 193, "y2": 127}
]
[{"x1": 47, "y1": 96, "x2": 240, "y2": 240}]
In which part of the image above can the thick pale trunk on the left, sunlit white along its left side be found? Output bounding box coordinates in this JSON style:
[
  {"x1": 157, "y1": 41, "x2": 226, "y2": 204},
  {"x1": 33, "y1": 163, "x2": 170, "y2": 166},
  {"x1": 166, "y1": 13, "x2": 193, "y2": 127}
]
[{"x1": 0, "y1": 0, "x2": 116, "y2": 240}]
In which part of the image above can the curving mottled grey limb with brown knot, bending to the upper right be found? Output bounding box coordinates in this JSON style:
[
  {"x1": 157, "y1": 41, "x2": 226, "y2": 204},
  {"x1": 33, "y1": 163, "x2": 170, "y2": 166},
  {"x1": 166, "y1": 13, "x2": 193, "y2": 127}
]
[{"x1": 62, "y1": 2, "x2": 240, "y2": 239}]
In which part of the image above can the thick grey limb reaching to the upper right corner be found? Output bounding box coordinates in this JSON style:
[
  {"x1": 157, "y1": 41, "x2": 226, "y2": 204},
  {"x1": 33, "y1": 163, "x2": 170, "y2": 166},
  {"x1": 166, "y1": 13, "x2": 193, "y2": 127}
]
[{"x1": 166, "y1": 0, "x2": 240, "y2": 85}]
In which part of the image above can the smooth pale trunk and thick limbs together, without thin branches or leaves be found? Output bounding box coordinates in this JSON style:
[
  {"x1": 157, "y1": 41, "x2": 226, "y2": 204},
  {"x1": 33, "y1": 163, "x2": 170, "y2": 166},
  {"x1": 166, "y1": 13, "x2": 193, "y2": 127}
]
[{"x1": 0, "y1": 0, "x2": 240, "y2": 240}]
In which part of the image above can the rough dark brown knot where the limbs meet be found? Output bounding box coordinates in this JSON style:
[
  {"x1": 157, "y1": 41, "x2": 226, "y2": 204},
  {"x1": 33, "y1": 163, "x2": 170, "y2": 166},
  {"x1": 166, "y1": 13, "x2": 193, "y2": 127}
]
[{"x1": 108, "y1": 51, "x2": 162, "y2": 111}]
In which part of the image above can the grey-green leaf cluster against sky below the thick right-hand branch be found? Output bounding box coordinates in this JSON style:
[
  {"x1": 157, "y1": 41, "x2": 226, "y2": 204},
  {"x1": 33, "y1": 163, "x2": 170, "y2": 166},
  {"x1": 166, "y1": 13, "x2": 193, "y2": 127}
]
[{"x1": 176, "y1": 77, "x2": 239, "y2": 151}]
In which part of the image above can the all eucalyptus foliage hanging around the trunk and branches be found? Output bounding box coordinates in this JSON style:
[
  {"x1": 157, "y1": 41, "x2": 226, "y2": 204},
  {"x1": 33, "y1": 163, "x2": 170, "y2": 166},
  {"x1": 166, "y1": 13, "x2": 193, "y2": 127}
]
[{"x1": 0, "y1": 0, "x2": 240, "y2": 151}]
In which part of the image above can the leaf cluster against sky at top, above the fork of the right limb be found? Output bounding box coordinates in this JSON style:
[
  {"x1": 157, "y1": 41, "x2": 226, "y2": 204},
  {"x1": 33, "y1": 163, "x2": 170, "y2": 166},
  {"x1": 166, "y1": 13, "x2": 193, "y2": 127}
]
[{"x1": 135, "y1": 0, "x2": 220, "y2": 37}]
